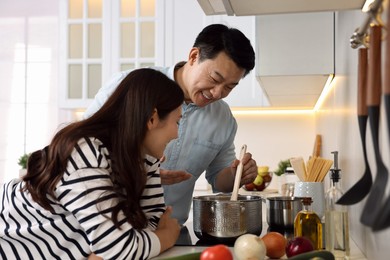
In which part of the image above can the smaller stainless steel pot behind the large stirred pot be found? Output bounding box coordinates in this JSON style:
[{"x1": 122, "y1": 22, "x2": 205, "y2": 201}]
[{"x1": 266, "y1": 196, "x2": 302, "y2": 229}]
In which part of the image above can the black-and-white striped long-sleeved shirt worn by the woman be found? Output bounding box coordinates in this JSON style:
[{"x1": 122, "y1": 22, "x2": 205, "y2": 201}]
[{"x1": 0, "y1": 138, "x2": 165, "y2": 260}]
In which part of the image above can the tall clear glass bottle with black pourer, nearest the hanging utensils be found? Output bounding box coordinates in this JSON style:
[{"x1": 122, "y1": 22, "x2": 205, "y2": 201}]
[{"x1": 325, "y1": 151, "x2": 350, "y2": 259}]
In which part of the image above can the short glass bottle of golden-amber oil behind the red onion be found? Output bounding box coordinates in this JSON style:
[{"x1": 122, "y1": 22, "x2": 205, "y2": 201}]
[{"x1": 294, "y1": 197, "x2": 323, "y2": 250}]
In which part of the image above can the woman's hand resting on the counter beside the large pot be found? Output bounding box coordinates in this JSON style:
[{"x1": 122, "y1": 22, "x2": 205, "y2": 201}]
[{"x1": 155, "y1": 206, "x2": 180, "y2": 253}]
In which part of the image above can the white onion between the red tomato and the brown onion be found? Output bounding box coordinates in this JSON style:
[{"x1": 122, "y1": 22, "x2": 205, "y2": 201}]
[{"x1": 234, "y1": 234, "x2": 266, "y2": 260}]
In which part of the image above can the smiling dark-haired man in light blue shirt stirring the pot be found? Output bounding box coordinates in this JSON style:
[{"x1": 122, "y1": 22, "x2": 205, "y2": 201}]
[{"x1": 85, "y1": 24, "x2": 257, "y2": 224}]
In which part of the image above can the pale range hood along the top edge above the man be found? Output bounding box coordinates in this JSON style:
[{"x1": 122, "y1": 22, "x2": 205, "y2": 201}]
[{"x1": 198, "y1": 0, "x2": 365, "y2": 16}]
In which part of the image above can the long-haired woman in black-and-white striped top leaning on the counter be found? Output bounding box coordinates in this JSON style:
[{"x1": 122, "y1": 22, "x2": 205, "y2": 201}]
[{"x1": 0, "y1": 69, "x2": 184, "y2": 259}]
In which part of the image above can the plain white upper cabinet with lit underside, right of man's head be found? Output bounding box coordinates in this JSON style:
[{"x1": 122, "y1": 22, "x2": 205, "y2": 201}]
[{"x1": 256, "y1": 12, "x2": 335, "y2": 108}]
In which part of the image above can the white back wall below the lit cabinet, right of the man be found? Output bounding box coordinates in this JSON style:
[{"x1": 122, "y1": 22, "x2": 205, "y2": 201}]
[{"x1": 235, "y1": 113, "x2": 316, "y2": 170}]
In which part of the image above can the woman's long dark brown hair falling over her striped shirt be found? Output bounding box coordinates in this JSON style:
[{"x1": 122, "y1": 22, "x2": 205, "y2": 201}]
[{"x1": 23, "y1": 69, "x2": 184, "y2": 229}]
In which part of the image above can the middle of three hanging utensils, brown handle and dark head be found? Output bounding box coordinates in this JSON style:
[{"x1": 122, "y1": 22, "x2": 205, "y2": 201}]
[{"x1": 360, "y1": 25, "x2": 389, "y2": 227}]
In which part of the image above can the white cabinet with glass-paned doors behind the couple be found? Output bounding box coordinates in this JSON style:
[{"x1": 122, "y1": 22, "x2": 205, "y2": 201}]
[{"x1": 60, "y1": 0, "x2": 164, "y2": 109}]
